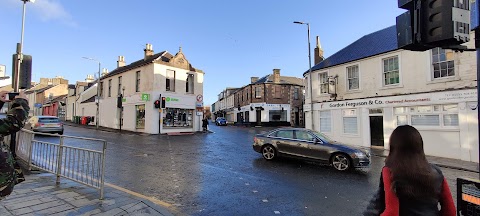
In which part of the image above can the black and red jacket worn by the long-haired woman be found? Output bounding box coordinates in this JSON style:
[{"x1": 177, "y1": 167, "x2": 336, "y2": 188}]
[{"x1": 363, "y1": 165, "x2": 444, "y2": 216}]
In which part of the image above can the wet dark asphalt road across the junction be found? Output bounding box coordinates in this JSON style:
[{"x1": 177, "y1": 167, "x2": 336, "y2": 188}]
[{"x1": 34, "y1": 125, "x2": 478, "y2": 215}]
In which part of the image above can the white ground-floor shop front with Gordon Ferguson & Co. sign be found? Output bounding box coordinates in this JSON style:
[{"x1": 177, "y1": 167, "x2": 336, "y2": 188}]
[{"x1": 313, "y1": 89, "x2": 478, "y2": 162}]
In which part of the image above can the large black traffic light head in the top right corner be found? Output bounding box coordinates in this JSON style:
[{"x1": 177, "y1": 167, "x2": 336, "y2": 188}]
[{"x1": 396, "y1": 0, "x2": 470, "y2": 51}]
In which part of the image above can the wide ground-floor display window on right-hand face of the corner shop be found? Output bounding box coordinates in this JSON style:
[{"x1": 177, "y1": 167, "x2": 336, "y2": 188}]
[{"x1": 163, "y1": 108, "x2": 193, "y2": 128}]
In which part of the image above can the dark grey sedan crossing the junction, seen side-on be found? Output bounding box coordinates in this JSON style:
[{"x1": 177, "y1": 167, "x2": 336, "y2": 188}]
[{"x1": 253, "y1": 128, "x2": 370, "y2": 171}]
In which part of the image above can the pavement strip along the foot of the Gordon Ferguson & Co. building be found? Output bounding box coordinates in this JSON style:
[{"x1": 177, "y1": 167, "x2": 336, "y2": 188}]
[{"x1": 370, "y1": 148, "x2": 479, "y2": 173}]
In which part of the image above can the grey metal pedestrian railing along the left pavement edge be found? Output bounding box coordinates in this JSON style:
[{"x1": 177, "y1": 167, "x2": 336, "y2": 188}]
[{"x1": 16, "y1": 129, "x2": 107, "y2": 199}]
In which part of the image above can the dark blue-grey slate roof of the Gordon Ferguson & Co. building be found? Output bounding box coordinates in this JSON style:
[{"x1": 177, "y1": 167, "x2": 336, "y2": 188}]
[{"x1": 303, "y1": 26, "x2": 398, "y2": 76}]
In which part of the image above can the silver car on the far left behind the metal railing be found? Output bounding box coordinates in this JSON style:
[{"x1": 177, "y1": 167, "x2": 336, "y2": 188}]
[{"x1": 27, "y1": 116, "x2": 63, "y2": 135}]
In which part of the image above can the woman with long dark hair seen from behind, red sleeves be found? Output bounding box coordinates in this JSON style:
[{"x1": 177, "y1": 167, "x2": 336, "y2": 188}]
[{"x1": 364, "y1": 125, "x2": 456, "y2": 216}]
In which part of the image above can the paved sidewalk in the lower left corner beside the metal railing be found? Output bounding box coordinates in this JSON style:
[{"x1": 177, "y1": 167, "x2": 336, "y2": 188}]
[{"x1": 0, "y1": 173, "x2": 180, "y2": 216}]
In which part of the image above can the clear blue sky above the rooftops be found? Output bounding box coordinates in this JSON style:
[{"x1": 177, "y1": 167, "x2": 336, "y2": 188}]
[{"x1": 0, "y1": 0, "x2": 403, "y2": 105}]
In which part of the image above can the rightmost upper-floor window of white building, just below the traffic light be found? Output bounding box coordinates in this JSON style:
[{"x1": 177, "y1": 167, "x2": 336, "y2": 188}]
[{"x1": 432, "y1": 48, "x2": 455, "y2": 79}]
